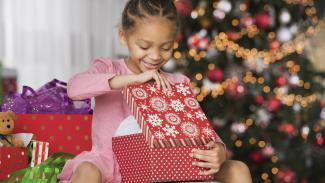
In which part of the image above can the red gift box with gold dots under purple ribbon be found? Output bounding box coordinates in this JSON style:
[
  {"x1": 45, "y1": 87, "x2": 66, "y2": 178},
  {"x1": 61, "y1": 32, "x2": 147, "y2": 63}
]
[{"x1": 13, "y1": 114, "x2": 92, "y2": 156}]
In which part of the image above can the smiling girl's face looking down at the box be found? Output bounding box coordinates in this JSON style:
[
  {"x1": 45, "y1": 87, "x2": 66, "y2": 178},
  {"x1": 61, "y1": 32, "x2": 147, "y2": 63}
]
[{"x1": 119, "y1": 17, "x2": 176, "y2": 73}]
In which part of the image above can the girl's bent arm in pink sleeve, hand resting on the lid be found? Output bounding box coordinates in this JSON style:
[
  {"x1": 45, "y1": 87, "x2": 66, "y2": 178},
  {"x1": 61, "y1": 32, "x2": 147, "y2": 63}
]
[{"x1": 68, "y1": 59, "x2": 171, "y2": 100}]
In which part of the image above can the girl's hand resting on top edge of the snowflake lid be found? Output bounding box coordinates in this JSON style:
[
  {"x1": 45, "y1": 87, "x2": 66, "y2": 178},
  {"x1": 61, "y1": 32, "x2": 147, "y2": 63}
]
[{"x1": 137, "y1": 70, "x2": 173, "y2": 90}]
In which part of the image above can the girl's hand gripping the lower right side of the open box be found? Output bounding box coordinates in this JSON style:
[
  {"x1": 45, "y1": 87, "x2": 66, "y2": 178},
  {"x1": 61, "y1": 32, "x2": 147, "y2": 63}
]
[{"x1": 190, "y1": 141, "x2": 226, "y2": 175}]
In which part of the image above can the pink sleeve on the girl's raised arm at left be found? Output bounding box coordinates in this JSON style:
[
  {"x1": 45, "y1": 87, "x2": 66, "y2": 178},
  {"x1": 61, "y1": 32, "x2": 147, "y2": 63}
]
[{"x1": 67, "y1": 58, "x2": 116, "y2": 100}]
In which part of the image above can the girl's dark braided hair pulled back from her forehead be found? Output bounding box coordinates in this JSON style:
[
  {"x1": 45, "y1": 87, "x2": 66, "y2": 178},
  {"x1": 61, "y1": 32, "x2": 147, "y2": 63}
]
[{"x1": 122, "y1": 0, "x2": 179, "y2": 30}]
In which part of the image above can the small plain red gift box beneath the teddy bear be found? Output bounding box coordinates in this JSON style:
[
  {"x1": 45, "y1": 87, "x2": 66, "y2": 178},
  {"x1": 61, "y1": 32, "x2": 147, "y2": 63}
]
[{"x1": 0, "y1": 147, "x2": 28, "y2": 180}]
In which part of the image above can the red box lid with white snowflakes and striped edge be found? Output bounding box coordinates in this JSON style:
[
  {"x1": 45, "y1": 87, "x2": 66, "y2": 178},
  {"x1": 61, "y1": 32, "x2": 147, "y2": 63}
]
[{"x1": 123, "y1": 83, "x2": 220, "y2": 148}]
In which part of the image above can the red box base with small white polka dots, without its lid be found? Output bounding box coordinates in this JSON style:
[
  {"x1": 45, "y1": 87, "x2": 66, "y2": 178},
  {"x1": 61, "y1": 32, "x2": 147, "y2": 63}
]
[{"x1": 113, "y1": 134, "x2": 213, "y2": 183}]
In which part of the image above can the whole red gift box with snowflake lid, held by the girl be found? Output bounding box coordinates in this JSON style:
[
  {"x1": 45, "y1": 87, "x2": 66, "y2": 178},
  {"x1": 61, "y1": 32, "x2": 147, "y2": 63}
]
[{"x1": 113, "y1": 83, "x2": 222, "y2": 183}]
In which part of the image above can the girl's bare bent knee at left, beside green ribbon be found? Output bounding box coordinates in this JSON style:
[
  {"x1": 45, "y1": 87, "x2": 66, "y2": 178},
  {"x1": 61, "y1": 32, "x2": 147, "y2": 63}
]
[{"x1": 74, "y1": 162, "x2": 101, "y2": 178}]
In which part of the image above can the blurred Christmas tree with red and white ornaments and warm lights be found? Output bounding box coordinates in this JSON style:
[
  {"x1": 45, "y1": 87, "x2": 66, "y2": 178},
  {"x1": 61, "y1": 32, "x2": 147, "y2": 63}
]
[{"x1": 165, "y1": 0, "x2": 325, "y2": 183}]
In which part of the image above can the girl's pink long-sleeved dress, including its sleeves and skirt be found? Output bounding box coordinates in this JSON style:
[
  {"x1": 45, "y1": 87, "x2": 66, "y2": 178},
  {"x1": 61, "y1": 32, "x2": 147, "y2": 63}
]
[{"x1": 58, "y1": 58, "x2": 189, "y2": 183}]
